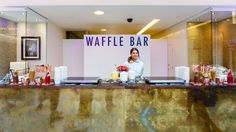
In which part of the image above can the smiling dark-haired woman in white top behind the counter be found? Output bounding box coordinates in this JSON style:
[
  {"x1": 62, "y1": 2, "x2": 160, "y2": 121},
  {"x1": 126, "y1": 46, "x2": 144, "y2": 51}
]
[{"x1": 124, "y1": 48, "x2": 144, "y2": 78}]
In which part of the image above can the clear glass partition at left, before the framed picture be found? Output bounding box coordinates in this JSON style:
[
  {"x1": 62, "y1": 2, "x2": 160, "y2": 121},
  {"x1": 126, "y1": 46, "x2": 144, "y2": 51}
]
[{"x1": 0, "y1": 7, "x2": 47, "y2": 79}]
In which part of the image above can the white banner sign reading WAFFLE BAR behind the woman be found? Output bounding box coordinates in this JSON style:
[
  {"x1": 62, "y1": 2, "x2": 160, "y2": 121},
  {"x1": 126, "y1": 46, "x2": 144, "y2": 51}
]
[{"x1": 84, "y1": 35, "x2": 150, "y2": 78}]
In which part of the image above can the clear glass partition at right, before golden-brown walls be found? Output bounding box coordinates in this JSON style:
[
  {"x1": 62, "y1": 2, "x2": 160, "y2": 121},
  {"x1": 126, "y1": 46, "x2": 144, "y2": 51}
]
[{"x1": 187, "y1": 9, "x2": 236, "y2": 79}]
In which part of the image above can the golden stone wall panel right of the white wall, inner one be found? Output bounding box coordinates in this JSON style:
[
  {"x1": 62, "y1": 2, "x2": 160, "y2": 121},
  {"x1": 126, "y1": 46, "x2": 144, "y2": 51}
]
[{"x1": 188, "y1": 22, "x2": 213, "y2": 66}]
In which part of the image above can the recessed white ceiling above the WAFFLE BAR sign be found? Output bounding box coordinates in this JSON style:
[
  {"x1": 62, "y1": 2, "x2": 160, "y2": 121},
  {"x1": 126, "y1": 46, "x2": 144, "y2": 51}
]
[{"x1": 30, "y1": 6, "x2": 209, "y2": 35}]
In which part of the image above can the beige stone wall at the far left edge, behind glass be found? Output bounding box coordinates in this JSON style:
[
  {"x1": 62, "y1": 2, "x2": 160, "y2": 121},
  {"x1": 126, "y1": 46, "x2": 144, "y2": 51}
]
[{"x1": 0, "y1": 18, "x2": 16, "y2": 79}]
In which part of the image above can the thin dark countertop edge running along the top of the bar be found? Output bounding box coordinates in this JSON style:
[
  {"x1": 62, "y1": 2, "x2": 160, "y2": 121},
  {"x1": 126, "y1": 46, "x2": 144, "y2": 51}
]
[{"x1": 0, "y1": 82, "x2": 236, "y2": 90}]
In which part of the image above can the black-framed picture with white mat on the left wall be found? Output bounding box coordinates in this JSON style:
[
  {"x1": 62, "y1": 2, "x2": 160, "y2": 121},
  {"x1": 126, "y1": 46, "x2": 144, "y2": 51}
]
[{"x1": 21, "y1": 37, "x2": 41, "y2": 60}]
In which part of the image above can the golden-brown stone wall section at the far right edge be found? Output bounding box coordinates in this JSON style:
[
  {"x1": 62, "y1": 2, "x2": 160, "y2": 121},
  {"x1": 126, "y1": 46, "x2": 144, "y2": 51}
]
[{"x1": 214, "y1": 18, "x2": 236, "y2": 71}]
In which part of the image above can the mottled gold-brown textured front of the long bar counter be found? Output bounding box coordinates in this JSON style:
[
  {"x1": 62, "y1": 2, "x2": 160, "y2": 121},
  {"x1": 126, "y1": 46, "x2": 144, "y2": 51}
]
[{"x1": 0, "y1": 84, "x2": 236, "y2": 132}]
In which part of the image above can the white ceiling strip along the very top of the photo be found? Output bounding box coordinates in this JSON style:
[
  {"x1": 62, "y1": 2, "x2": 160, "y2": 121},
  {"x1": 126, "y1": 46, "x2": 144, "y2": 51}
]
[{"x1": 0, "y1": 0, "x2": 236, "y2": 6}]
